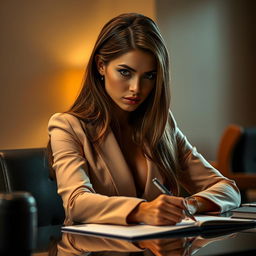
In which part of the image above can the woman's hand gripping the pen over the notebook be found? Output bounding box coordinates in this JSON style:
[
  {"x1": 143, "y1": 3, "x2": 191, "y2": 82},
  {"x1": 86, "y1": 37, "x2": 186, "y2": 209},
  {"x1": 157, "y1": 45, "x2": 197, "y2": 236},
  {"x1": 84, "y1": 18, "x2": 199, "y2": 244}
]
[{"x1": 127, "y1": 194, "x2": 185, "y2": 225}]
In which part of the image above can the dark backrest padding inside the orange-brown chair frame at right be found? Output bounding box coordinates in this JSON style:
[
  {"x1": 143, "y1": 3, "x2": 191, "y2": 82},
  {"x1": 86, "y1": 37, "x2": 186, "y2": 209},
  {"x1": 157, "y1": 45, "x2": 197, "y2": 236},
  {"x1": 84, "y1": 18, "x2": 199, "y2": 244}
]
[{"x1": 231, "y1": 127, "x2": 256, "y2": 173}]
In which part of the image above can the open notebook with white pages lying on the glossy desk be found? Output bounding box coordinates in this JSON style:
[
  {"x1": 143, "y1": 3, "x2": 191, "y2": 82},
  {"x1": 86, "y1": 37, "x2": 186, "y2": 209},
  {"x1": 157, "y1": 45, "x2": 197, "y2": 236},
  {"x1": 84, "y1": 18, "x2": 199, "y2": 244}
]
[{"x1": 62, "y1": 216, "x2": 256, "y2": 241}]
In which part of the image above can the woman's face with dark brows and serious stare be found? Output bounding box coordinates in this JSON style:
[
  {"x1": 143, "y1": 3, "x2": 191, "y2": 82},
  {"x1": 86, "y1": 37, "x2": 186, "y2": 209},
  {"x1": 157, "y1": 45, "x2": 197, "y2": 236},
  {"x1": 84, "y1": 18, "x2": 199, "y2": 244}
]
[{"x1": 97, "y1": 50, "x2": 157, "y2": 112}]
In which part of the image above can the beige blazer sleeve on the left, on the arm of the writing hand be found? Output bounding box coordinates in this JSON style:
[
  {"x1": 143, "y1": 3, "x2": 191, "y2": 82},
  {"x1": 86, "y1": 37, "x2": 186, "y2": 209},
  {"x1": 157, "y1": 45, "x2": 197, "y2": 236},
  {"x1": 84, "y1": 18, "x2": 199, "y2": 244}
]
[{"x1": 48, "y1": 113, "x2": 143, "y2": 224}]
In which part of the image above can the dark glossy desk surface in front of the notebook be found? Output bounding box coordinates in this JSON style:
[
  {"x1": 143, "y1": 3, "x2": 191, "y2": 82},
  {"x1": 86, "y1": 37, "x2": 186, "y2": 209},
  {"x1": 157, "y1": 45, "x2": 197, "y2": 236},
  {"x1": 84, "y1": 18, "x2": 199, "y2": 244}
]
[{"x1": 33, "y1": 226, "x2": 256, "y2": 256}]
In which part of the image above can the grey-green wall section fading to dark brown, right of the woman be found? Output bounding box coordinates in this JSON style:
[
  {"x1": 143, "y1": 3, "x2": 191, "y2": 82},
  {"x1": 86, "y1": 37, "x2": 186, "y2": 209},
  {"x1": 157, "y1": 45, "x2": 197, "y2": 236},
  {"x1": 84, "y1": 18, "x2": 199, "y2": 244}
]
[{"x1": 156, "y1": 0, "x2": 256, "y2": 159}]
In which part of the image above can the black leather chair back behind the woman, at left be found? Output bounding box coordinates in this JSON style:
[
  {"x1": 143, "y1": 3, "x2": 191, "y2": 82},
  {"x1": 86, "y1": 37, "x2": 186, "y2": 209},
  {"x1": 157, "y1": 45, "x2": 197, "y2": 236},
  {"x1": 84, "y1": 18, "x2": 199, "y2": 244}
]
[{"x1": 0, "y1": 148, "x2": 65, "y2": 226}]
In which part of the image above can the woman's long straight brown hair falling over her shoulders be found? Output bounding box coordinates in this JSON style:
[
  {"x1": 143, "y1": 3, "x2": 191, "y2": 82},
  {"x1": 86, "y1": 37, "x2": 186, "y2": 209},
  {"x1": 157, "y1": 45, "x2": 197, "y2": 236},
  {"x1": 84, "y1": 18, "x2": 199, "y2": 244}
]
[{"x1": 49, "y1": 13, "x2": 179, "y2": 194}]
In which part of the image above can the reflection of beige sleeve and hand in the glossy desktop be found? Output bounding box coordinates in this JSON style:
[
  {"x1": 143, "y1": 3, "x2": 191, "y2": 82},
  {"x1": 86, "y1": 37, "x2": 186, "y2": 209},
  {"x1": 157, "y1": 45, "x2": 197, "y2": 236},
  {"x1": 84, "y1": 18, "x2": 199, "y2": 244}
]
[{"x1": 54, "y1": 233, "x2": 235, "y2": 256}]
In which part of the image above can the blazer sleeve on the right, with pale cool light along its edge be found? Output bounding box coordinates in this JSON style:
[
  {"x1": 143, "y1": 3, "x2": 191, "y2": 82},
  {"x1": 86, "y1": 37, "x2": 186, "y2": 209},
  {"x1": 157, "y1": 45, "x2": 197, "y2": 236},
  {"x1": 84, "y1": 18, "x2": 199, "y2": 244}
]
[{"x1": 173, "y1": 117, "x2": 241, "y2": 212}]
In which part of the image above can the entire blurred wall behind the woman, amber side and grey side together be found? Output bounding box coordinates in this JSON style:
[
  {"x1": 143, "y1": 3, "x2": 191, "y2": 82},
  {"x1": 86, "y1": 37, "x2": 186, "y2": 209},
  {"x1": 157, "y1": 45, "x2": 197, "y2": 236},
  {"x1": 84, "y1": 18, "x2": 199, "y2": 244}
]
[{"x1": 0, "y1": 0, "x2": 256, "y2": 159}]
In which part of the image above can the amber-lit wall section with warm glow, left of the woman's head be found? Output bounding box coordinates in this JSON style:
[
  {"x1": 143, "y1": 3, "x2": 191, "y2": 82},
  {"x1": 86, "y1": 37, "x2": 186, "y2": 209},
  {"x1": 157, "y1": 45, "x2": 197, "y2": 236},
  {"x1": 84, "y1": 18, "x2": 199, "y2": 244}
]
[{"x1": 0, "y1": 0, "x2": 156, "y2": 149}]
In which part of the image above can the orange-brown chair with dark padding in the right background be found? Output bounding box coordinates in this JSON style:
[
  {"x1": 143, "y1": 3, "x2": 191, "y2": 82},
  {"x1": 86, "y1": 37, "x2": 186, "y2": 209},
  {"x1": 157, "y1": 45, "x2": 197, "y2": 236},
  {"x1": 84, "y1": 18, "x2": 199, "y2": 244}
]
[{"x1": 212, "y1": 125, "x2": 256, "y2": 201}]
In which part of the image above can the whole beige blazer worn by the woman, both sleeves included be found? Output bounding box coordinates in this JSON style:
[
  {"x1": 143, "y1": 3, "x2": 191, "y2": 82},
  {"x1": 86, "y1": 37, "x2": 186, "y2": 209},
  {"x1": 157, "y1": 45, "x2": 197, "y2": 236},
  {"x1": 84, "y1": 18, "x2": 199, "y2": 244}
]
[{"x1": 48, "y1": 113, "x2": 240, "y2": 224}]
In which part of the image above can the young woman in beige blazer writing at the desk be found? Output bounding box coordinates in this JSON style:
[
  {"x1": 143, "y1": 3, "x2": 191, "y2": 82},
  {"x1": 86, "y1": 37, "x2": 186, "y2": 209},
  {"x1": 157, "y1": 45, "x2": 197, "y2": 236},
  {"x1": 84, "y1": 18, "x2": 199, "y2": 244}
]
[{"x1": 49, "y1": 13, "x2": 240, "y2": 225}]
